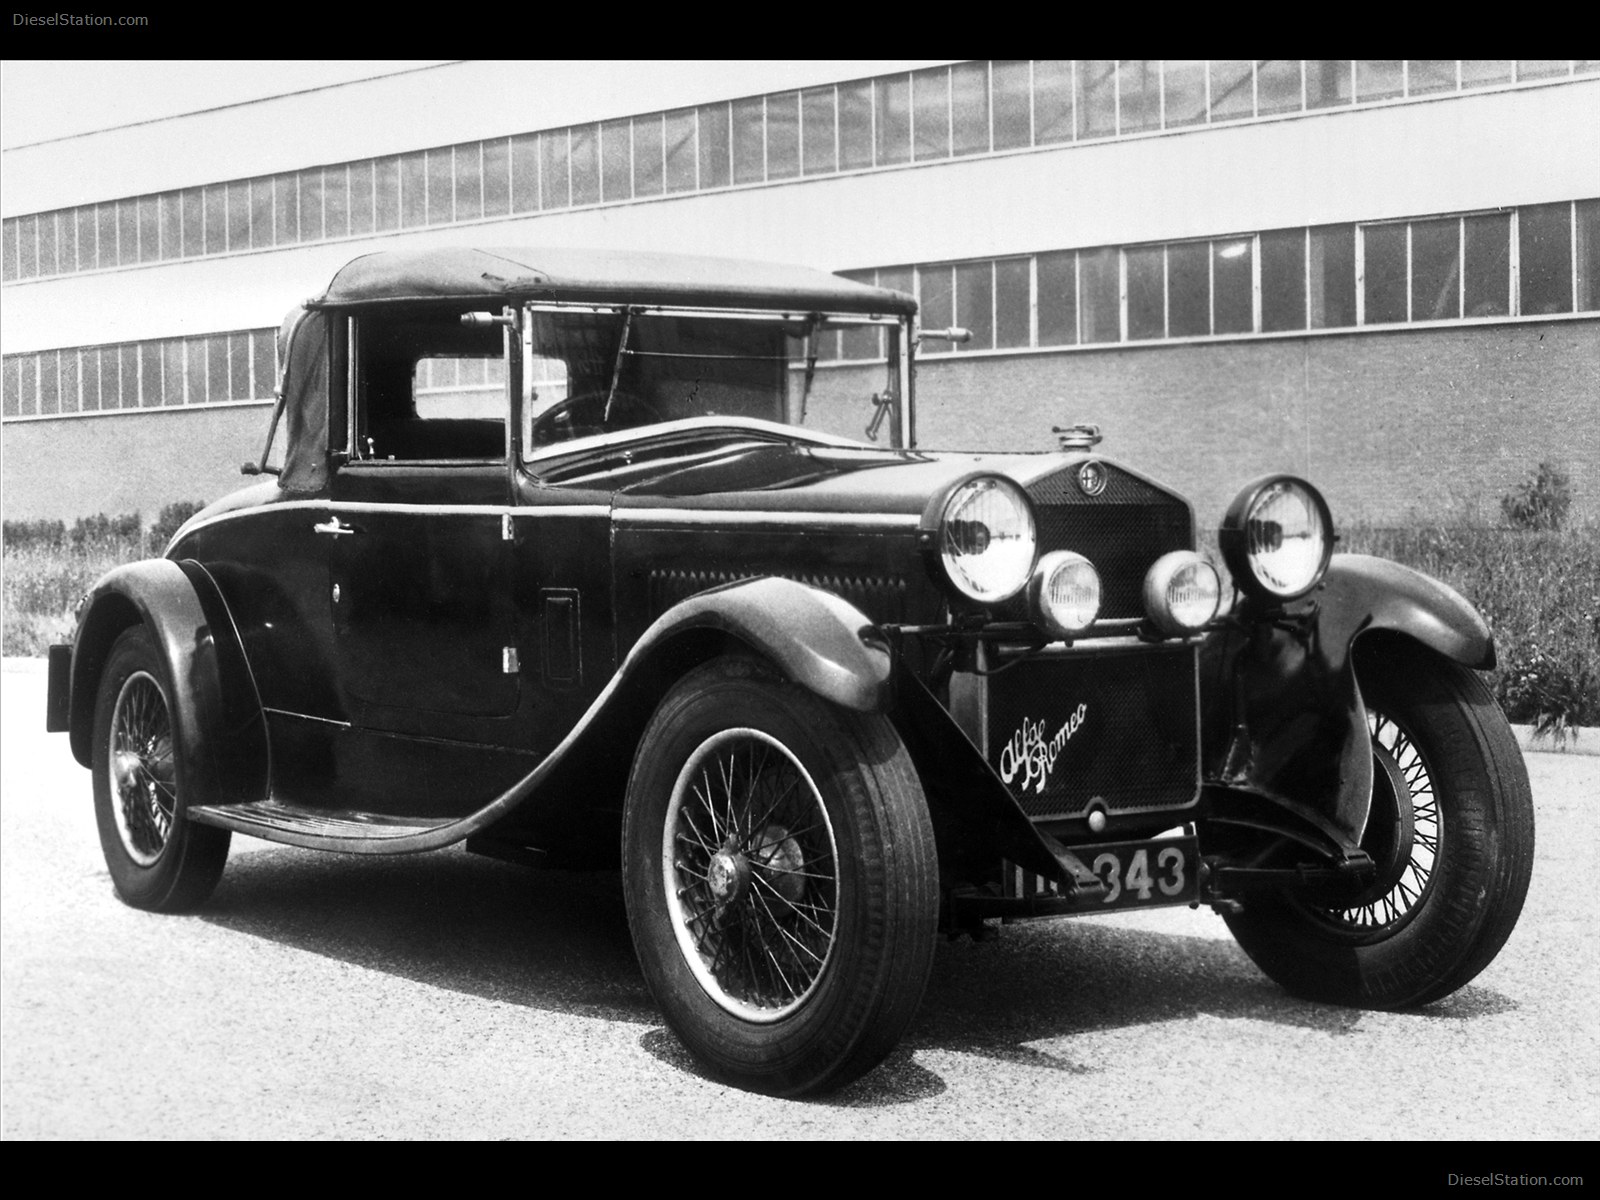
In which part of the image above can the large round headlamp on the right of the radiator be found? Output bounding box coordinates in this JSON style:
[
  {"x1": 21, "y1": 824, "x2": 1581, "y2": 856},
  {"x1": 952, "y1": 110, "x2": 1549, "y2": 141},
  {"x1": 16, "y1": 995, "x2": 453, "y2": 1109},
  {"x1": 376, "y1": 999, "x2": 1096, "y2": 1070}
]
[{"x1": 1218, "y1": 475, "x2": 1333, "y2": 603}]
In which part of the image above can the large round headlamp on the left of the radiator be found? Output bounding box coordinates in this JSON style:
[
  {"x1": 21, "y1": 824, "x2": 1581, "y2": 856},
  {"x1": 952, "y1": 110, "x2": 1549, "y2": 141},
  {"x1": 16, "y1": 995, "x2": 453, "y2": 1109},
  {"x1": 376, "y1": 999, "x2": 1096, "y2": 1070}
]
[{"x1": 936, "y1": 475, "x2": 1038, "y2": 605}]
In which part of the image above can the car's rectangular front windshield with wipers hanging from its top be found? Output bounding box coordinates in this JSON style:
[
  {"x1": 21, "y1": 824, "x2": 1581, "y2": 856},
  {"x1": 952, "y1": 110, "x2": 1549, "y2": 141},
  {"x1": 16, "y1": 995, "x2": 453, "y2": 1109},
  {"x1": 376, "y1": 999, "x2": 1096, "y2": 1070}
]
[{"x1": 522, "y1": 306, "x2": 901, "y2": 454}]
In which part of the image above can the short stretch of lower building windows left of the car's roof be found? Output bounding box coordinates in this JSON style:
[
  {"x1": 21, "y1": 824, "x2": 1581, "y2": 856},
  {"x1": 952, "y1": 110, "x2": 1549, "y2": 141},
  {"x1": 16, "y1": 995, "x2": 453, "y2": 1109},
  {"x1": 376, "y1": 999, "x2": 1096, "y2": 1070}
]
[{"x1": 3, "y1": 330, "x2": 277, "y2": 418}]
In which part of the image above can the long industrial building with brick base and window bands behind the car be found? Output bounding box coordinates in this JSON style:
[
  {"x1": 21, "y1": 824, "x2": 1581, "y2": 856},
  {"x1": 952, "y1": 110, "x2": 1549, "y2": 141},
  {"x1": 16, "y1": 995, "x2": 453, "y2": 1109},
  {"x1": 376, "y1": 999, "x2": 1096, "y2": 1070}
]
[{"x1": 0, "y1": 59, "x2": 1600, "y2": 525}]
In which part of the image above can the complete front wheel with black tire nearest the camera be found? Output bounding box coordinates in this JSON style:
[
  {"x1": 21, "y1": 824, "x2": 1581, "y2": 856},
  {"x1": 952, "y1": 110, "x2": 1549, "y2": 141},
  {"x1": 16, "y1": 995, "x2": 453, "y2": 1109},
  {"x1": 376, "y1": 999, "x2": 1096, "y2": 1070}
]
[{"x1": 622, "y1": 658, "x2": 939, "y2": 1096}]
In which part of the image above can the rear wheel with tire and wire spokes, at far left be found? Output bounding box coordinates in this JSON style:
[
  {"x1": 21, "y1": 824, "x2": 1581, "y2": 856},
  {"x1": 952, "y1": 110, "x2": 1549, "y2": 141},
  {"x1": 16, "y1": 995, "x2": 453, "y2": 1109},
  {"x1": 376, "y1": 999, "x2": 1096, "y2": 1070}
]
[{"x1": 93, "y1": 626, "x2": 230, "y2": 912}]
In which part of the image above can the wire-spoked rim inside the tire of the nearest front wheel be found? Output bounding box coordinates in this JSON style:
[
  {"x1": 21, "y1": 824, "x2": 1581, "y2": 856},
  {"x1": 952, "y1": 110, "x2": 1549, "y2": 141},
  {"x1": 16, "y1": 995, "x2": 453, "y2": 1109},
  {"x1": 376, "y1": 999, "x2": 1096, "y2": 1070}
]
[{"x1": 661, "y1": 728, "x2": 840, "y2": 1021}]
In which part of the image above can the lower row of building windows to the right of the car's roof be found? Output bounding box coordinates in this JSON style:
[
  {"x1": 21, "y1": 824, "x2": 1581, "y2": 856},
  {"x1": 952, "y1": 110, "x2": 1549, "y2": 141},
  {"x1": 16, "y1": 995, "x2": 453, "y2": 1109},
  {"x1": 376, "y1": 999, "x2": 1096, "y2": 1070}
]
[{"x1": 824, "y1": 200, "x2": 1600, "y2": 358}]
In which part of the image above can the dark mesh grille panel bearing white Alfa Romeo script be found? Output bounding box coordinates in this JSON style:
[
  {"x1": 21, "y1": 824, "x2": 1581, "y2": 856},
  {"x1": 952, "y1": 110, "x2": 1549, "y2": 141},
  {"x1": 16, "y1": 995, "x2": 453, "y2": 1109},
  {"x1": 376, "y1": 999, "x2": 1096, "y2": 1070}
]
[{"x1": 987, "y1": 645, "x2": 1200, "y2": 818}]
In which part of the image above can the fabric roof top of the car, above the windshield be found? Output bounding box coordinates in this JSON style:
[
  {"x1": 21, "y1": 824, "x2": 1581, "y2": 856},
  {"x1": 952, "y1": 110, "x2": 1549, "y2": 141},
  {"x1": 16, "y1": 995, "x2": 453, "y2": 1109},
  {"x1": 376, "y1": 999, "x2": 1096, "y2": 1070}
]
[{"x1": 307, "y1": 246, "x2": 917, "y2": 315}]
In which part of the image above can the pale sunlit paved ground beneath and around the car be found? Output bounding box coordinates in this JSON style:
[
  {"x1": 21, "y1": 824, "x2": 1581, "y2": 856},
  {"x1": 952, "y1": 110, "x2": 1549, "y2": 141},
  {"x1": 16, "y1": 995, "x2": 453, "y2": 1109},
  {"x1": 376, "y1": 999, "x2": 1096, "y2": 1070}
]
[{"x1": 0, "y1": 661, "x2": 1600, "y2": 1141}]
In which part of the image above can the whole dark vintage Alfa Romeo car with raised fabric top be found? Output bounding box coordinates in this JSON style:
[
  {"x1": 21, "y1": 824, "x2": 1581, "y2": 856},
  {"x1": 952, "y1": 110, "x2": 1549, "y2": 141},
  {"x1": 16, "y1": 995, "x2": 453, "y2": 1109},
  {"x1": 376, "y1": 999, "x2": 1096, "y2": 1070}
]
[{"x1": 48, "y1": 248, "x2": 1533, "y2": 1094}]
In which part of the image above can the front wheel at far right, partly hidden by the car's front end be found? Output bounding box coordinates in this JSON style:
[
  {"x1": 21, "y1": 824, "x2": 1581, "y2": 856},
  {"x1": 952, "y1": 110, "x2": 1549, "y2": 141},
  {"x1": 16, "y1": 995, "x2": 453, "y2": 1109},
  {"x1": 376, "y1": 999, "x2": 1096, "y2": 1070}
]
[{"x1": 1227, "y1": 638, "x2": 1533, "y2": 1010}]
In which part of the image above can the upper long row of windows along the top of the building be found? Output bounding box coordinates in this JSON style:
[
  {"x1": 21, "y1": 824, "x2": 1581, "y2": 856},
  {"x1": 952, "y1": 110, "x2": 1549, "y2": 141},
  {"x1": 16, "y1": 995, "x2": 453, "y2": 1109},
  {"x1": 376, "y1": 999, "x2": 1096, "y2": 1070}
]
[{"x1": 3, "y1": 59, "x2": 1600, "y2": 283}]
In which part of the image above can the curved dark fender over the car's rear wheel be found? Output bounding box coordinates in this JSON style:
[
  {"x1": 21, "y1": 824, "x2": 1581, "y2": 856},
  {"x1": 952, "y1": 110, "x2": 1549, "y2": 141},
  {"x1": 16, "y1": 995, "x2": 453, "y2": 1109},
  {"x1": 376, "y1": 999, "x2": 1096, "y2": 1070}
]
[{"x1": 70, "y1": 558, "x2": 269, "y2": 805}]
